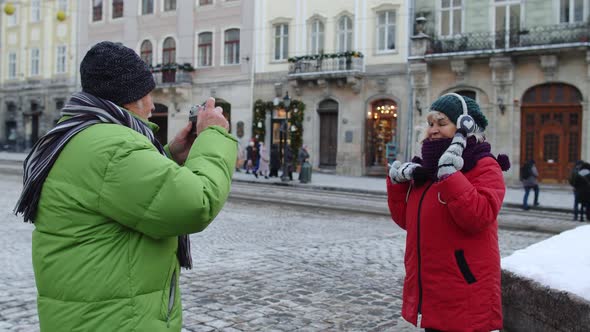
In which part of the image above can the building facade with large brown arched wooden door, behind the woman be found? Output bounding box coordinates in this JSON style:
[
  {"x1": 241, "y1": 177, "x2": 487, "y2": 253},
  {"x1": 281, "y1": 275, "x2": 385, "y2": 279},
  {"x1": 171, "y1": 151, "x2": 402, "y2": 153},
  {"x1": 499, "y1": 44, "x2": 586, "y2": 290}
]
[{"x1": 409, "y1": 0, "x2": 590, "y2": 183}]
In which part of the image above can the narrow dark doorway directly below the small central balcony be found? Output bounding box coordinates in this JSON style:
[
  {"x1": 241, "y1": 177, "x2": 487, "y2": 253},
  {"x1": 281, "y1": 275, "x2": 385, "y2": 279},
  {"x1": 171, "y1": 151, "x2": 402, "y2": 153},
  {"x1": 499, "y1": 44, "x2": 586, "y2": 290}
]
[{"x1": 318, "y1": 99, "x2": 338, "y2": 168}]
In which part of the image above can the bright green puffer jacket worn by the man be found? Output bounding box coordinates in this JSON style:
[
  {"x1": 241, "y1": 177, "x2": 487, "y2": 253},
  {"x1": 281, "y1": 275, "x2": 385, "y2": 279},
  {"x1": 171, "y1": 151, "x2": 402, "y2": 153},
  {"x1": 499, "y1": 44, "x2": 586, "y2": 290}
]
[{"x1": 33, "y1": 118, "x2": 237, "y2": 332}]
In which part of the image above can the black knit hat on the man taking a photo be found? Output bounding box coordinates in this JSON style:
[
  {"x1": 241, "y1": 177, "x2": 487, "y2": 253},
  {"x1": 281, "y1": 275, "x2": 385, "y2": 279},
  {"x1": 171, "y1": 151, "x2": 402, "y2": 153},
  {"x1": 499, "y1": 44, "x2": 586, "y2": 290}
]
[{"x1": 80, "y1": 41, "x2": 156, "y2": 106}]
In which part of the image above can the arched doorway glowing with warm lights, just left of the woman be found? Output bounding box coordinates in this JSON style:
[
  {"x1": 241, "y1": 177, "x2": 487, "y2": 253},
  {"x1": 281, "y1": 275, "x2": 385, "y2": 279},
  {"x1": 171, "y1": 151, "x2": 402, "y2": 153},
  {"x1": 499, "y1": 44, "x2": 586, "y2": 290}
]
[{"x1": 365, "y1": 99, "x2": 398, "y2": 176}]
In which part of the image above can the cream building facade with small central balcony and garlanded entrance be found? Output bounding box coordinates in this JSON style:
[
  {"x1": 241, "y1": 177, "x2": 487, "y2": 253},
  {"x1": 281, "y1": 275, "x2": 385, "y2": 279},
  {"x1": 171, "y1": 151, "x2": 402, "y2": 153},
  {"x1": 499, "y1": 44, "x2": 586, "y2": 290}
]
[{"x1": 254, "y1": 0, "x2": 412, "y2": 176}]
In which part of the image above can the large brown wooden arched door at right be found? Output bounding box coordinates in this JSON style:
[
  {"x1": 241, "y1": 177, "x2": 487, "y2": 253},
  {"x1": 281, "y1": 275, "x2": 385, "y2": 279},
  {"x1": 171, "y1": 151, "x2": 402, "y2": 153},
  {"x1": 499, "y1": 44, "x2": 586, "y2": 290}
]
[{"x1": 520, "y1": 84, "x2": 582, "y2": 183}]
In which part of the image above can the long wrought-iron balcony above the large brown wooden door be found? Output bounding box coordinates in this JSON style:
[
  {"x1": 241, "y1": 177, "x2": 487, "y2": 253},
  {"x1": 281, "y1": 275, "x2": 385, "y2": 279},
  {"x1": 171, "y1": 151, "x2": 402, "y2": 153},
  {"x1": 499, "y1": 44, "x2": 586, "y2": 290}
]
[{"x1": 425, "y1": 22, "x2": 590, "y2": 55}]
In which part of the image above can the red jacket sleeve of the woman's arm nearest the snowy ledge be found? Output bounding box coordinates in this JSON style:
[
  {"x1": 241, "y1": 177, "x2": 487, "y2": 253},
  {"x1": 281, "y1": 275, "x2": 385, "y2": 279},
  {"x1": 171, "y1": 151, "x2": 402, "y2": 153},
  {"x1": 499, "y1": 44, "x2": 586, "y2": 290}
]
[{"x1": 439, "y1": 157, "x2": 506, "y2": 233}]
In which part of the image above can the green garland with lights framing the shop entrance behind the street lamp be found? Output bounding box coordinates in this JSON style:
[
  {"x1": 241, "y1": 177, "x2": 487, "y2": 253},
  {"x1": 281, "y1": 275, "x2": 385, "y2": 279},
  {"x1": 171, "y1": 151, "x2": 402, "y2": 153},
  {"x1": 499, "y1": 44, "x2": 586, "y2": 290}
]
[{"x1": 252, "y1": 99, "x2": 305, "y2": 159}]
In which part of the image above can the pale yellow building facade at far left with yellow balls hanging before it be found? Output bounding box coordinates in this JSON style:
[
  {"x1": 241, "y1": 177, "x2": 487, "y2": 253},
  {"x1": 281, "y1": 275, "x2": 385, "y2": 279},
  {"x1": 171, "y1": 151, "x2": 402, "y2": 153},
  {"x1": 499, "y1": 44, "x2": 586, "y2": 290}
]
[{"x1": 0, "y1": 0, "x2": 78, "y2": 151}]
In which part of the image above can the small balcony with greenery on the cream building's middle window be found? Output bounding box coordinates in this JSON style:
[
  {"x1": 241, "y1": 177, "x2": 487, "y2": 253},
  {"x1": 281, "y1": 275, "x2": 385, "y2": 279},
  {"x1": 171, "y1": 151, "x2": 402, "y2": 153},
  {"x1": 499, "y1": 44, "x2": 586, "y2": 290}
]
[{"x1": 288, "y1": 52, "x2": 364, "y2": 80}]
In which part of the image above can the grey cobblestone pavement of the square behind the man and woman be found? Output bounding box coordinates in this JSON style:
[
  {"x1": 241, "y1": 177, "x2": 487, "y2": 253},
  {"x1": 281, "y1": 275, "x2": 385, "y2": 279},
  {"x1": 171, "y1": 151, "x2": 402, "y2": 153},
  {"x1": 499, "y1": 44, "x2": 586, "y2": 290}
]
[{"x1": 0, "y1": 175, "x2": 549, "y2": 332}]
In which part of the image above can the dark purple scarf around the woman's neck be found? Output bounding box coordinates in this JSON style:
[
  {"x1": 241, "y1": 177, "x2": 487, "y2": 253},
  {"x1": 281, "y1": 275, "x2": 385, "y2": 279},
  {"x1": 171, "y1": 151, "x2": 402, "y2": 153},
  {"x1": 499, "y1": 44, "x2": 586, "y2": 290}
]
[{"x1": 412, "y1": 136, "x2": 510, "y2": 185}]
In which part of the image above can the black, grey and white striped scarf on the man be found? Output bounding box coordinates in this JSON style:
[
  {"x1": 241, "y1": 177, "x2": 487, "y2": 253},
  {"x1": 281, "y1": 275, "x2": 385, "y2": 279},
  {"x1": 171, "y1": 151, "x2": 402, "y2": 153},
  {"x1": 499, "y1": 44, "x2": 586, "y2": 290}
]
[{"x1": 13, "y1": 92, "x2": 192, "y2": 269}]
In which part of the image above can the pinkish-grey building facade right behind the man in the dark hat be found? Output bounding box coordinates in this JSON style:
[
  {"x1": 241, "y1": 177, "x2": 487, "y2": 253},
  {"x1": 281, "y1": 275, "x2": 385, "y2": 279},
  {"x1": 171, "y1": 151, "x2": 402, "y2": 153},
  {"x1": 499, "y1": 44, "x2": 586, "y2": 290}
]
[{"x1": 78, "y1": 0, "x2": 252, "y2": 148}]
